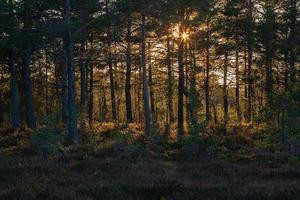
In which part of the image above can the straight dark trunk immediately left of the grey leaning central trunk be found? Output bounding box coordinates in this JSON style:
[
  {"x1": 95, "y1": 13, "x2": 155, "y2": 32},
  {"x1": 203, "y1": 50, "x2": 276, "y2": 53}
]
[{"x1": 125, "y1": 14, "x2": 133, "y2": 123}]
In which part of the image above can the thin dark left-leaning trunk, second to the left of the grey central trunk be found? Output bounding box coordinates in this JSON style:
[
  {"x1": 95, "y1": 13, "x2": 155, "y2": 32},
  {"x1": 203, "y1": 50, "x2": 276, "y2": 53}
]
[{"x1": 108, "y1": 42, "x2": 117, "y2": 122}]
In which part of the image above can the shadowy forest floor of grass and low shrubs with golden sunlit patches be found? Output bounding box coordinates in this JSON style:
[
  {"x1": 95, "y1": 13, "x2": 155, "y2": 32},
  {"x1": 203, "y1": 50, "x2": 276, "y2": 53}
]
[{"x1": 0, "y1": 122, "x2": 300, "y2": 200}]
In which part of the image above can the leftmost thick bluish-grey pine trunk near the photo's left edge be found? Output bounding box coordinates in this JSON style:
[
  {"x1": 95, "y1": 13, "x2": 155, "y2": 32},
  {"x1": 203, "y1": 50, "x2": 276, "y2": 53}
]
[{"x1": 10, "y1": 52, "x2": 21, "y2": 130}]
